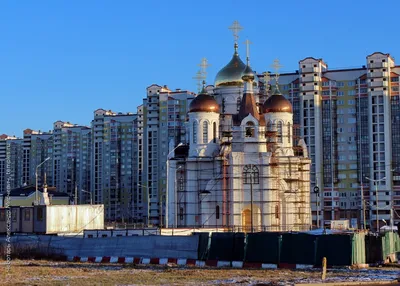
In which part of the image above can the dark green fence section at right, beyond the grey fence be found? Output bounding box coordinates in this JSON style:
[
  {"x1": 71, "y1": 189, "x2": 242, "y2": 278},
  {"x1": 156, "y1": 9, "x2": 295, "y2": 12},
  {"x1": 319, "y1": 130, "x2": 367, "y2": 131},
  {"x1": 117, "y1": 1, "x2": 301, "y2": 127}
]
[{"x1": 197, "y1": 232, "x2": 400, "y2": 267}]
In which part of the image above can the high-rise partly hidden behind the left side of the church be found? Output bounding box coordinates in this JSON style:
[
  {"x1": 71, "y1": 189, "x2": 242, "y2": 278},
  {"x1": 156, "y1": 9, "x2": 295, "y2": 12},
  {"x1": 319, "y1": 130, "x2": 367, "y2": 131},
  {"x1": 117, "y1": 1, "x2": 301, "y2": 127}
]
[{"x1": 138, "y1": 84, "x2": 195, "y2": 225}]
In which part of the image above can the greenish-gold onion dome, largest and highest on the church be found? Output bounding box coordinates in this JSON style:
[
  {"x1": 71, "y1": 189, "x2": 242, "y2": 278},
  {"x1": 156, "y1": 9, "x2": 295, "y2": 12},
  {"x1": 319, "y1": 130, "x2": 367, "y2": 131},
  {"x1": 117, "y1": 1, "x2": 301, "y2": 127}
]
[{"x1": 215, "y1": 43, "x2": 246, "y2": 87}]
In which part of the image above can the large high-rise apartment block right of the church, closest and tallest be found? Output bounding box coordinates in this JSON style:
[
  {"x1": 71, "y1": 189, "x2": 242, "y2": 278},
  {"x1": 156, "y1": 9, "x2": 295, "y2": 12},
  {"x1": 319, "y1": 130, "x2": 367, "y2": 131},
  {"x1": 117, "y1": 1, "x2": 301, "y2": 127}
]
[{"x1": 279, "y1": 52, "x2": 400, "y2": 229}]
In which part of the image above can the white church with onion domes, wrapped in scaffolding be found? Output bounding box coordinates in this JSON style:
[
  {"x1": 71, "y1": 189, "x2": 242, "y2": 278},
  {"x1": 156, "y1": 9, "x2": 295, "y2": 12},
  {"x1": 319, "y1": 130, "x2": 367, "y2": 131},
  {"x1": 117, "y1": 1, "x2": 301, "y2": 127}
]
[{"x1": 166, "y1": 22, "x2": 311, "y2": 232}]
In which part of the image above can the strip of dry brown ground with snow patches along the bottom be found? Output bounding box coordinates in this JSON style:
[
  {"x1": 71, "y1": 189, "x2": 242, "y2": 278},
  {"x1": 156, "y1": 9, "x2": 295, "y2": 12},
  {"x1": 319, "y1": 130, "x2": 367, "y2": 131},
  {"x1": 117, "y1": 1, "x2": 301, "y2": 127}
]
[{"x1": 0, "y1": 260, "x2": 400, "y2": 285}]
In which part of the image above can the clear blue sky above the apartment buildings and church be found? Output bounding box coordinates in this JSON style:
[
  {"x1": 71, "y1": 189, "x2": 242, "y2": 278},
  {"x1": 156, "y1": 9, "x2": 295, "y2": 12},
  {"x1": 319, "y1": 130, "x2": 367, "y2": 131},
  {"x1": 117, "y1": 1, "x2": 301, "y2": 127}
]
[{"x1": 0, "y1": 0, "x2": 400, "y2": 136}]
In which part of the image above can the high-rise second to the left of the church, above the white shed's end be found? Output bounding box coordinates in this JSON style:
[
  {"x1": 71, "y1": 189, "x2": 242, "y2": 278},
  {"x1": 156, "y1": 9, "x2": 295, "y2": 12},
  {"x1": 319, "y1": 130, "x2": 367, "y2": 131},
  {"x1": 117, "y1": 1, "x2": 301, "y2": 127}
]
[{"x1": 90, "y1": 109, "x2": 138, "y2": 222}]
